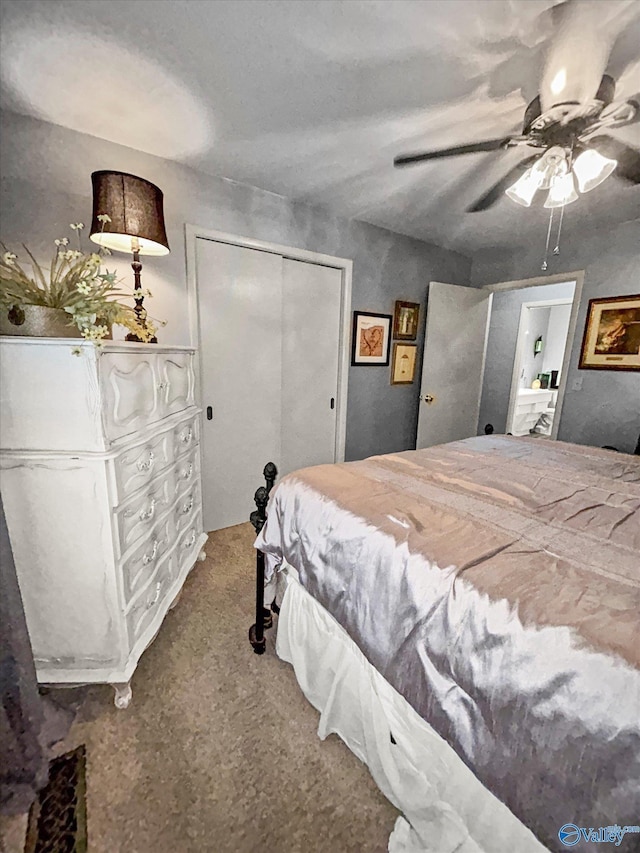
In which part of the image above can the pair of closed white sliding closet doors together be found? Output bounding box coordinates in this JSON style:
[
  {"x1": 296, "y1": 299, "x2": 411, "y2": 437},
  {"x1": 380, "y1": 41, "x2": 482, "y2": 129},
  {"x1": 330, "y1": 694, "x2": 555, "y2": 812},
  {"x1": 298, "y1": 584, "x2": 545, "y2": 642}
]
[{"x1": 196, "y1": 238, "x2": 346, "y2": 531}]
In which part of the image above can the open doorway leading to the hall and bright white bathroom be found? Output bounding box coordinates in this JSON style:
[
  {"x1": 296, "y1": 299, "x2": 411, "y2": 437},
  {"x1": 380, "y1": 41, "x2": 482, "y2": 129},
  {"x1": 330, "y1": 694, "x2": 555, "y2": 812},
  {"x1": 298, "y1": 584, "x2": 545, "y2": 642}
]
[{"x1": 477, "y1": 273, "x2": 582, "y2": 439}]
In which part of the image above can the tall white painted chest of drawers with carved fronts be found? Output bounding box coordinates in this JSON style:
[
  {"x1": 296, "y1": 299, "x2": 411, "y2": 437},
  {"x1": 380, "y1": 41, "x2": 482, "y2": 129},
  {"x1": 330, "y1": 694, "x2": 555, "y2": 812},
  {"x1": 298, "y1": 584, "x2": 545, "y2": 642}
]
[{"x1": 0, "y1": 337, "x2": 207, "y2": 707}]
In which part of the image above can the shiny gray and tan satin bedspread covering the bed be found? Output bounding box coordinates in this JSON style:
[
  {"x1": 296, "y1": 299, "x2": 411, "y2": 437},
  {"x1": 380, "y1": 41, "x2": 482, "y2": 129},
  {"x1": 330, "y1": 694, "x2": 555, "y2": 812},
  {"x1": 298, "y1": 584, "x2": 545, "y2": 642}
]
[{"x1": 256, "y1": 436, "x2": 640, "y2": 850}]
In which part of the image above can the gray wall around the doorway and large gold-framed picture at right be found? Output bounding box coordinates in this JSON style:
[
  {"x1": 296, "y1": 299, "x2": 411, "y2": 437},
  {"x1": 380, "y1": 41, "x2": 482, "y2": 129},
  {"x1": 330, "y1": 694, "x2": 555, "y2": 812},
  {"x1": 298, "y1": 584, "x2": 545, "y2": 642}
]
[{"x1": 471, "y1": 220, "x2": 640, "y2": 453}]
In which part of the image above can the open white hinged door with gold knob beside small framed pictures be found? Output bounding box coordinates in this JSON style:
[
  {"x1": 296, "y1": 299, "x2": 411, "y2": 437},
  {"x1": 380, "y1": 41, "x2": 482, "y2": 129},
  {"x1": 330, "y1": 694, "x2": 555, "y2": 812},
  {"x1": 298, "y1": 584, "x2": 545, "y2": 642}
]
[{"x1": 416, "y1": 281, "x2": 491, "y2": 448}]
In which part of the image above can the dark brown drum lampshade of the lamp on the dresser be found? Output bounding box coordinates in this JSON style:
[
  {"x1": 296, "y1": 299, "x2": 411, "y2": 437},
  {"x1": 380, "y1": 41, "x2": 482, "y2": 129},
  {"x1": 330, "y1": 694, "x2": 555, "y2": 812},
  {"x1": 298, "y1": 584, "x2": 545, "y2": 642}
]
[{"x1": 89, "y1": 171, "x2": 169, "y2": 255}]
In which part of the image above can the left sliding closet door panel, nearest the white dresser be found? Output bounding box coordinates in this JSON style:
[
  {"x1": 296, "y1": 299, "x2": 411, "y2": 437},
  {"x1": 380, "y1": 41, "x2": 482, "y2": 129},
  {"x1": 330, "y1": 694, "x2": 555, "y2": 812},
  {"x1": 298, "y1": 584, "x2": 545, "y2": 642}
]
[{"x1": 196, "y1": 238, "x2": 283, "y2": 531}]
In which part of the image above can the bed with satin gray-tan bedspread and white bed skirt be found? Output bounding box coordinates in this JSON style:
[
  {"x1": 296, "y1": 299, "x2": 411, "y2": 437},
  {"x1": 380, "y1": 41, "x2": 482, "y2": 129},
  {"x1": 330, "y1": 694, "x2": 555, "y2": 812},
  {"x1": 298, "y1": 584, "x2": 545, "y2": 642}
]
[{"x1": 248, "y1": 436, "x2": 640, "y2": 853}]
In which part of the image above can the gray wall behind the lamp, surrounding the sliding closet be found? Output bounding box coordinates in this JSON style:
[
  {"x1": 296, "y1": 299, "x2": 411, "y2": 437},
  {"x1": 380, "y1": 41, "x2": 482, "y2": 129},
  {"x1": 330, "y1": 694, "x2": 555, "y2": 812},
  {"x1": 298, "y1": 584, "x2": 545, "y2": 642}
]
[{"x1": 0, "y1": 113, "x2": 471, "y2": 459}]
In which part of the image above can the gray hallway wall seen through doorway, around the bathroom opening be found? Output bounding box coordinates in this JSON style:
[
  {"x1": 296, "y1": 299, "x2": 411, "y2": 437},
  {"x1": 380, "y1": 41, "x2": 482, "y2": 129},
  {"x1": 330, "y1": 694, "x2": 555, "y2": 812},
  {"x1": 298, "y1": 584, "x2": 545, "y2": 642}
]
[{"x1": 478, "y1": 282, "x2": 573, "y2": 435}]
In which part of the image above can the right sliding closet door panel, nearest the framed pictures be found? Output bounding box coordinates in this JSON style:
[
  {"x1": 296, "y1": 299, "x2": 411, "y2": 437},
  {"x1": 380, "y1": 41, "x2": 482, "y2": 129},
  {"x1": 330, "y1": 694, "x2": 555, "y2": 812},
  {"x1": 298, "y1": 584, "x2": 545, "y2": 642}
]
[{"x1": 281, "y1": 258, "x2": 342, "y2": 474}]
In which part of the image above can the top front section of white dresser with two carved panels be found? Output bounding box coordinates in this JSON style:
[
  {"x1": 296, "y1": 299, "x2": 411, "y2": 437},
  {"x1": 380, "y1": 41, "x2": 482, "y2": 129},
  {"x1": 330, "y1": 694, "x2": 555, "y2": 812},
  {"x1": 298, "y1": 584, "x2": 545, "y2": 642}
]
[{"x1": 99, "y1": 351, "x2": 194, "y2": 441}]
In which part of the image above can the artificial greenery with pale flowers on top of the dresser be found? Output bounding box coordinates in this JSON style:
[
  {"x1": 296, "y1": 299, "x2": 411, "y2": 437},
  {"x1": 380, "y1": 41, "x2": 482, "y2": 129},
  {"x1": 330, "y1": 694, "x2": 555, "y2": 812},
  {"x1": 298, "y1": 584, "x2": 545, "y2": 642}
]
[{"x1": 0, "y1": 214, "x2": 166, "y2": 343}]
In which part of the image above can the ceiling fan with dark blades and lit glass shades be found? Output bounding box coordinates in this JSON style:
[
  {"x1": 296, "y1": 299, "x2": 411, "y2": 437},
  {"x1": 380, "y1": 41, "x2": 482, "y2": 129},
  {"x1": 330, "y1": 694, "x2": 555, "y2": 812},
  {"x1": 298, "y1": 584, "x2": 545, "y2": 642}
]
[{"x1": 393, "y1": 3, "x2": 640, "y2": 212}]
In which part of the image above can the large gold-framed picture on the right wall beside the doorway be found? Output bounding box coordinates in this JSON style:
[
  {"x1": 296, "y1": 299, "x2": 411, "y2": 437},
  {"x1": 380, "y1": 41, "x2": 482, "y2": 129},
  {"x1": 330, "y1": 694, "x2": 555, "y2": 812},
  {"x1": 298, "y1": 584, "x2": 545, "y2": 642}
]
[{"x1": 578, "y1": 294, "x2": 640, "y2": 370}]
